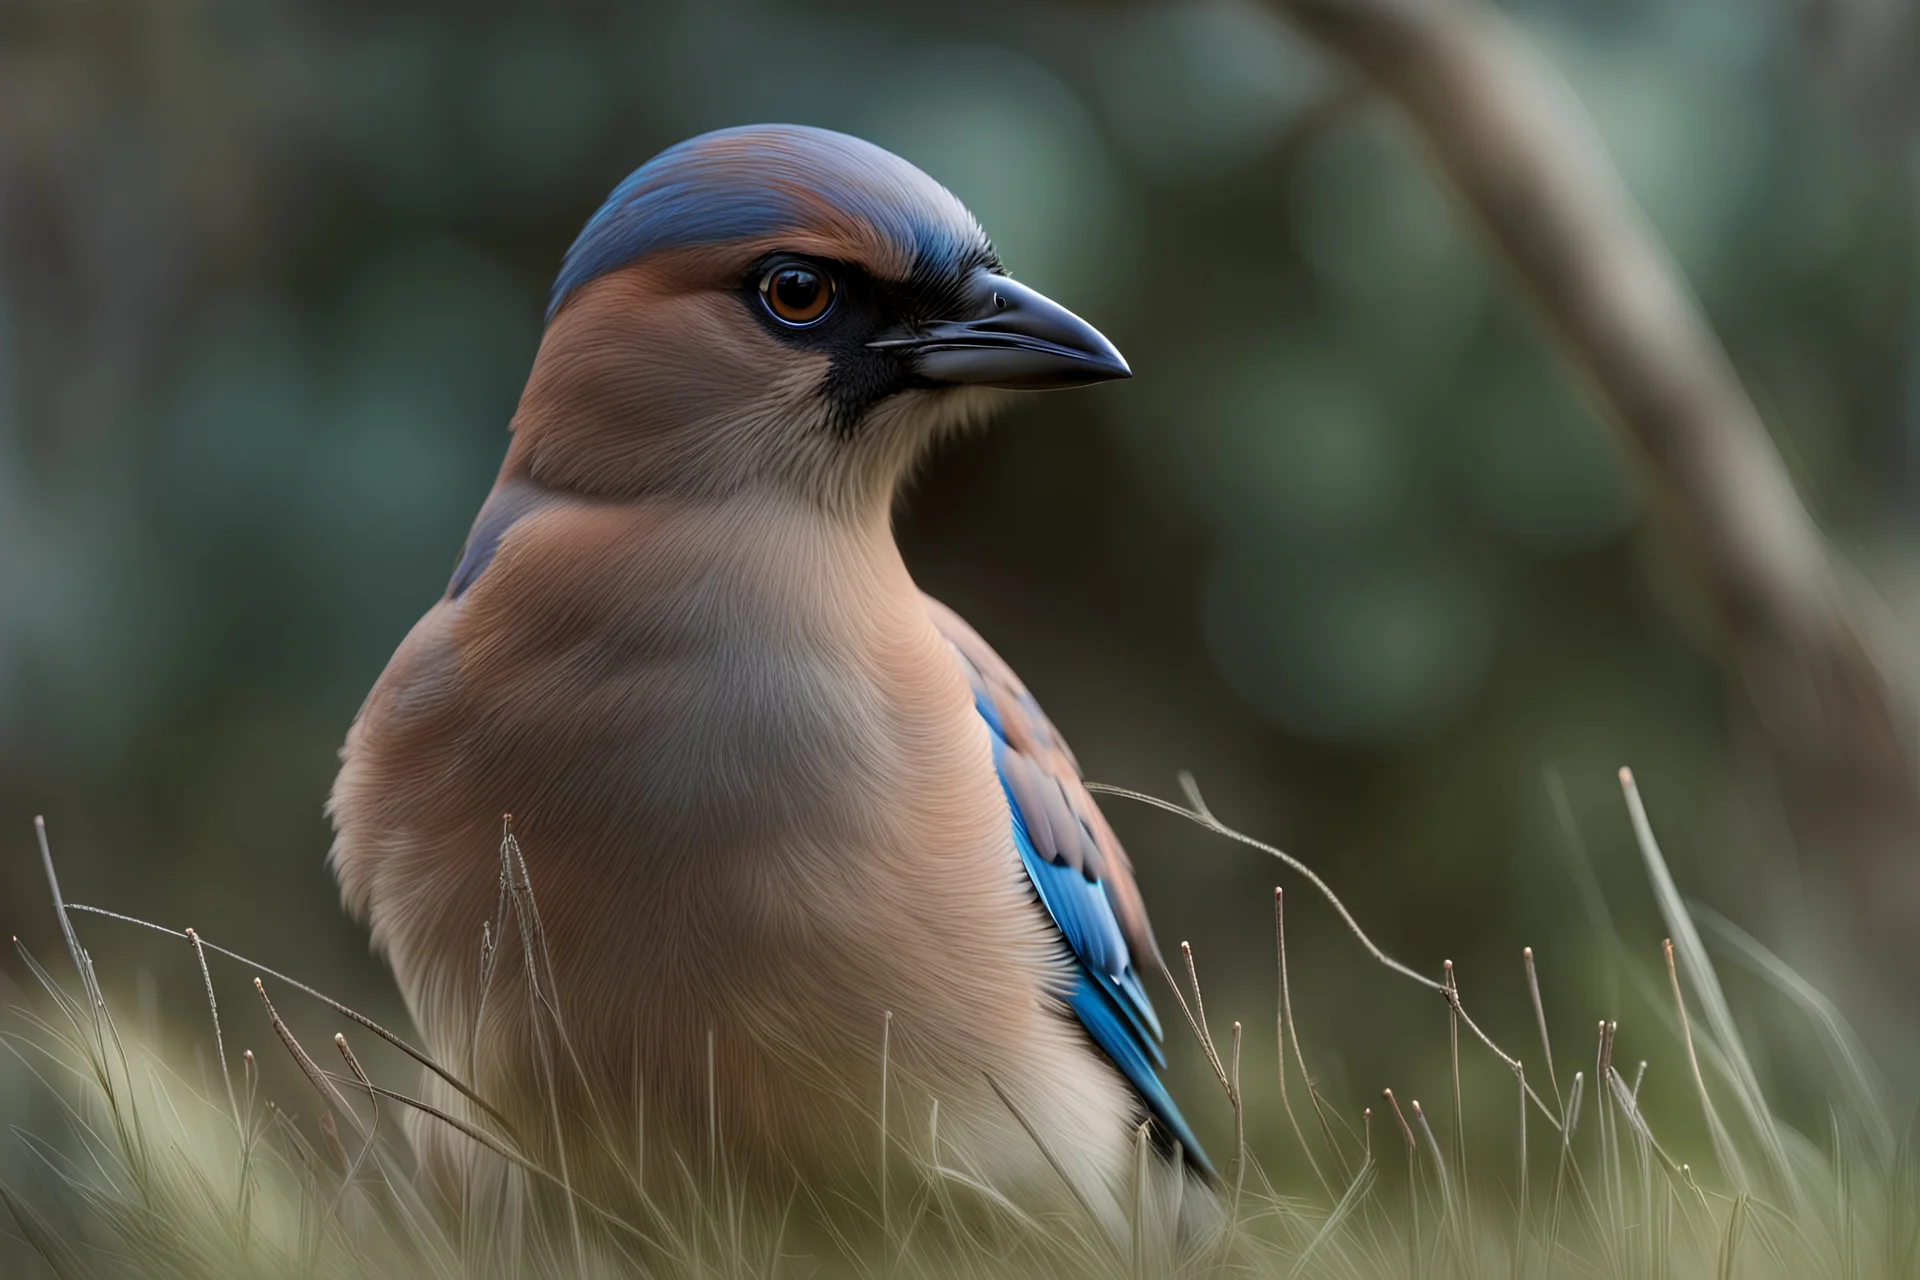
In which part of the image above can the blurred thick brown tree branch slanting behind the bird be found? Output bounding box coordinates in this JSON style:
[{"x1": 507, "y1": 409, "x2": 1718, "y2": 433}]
[{"x1": 1273, "y1": 0, "x2": 1920, "y2": 951}]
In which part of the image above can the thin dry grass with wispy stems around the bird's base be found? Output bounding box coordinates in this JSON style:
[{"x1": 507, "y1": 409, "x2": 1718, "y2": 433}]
[{"x1": 0, "y1": 771, "x2": 1920, "y2": 1280}]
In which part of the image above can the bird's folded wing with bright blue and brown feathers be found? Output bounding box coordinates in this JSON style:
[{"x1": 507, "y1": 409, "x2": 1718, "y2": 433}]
[{"x1": 927, "y1": 597, "x2": 1213, "y2": 1174}]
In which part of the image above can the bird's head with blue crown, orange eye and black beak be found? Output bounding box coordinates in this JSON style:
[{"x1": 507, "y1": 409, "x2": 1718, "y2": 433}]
[{"x1": 511, "y1": 125, "x2": 1127, "y2": 507}]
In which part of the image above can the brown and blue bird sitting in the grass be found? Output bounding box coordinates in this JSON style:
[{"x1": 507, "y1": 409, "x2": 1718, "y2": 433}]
[{"x1": 328, "y1": 125, "x2": 1213, "y2": 1221}]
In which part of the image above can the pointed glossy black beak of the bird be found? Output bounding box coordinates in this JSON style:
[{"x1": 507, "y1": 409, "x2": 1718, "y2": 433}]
[{"x1": 870, "y1": 271, "x2": 1133, "y2": 391}]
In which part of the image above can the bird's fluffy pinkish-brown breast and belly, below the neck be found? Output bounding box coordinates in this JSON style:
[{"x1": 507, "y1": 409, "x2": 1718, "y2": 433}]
[{"x1": 334, "y1": 491, "x2": 1104, "y2": 1189}]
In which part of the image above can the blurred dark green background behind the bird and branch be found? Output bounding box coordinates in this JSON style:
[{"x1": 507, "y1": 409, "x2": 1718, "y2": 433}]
[{"x1": 0, "y1": 0, "x2": 1920, "y2": 1205}]
